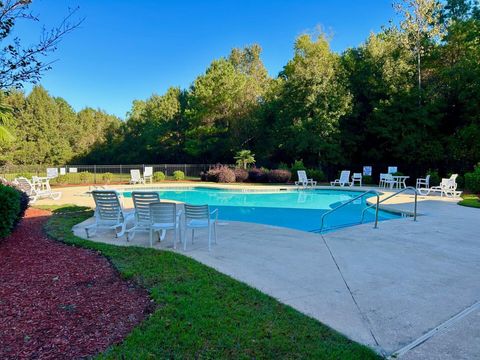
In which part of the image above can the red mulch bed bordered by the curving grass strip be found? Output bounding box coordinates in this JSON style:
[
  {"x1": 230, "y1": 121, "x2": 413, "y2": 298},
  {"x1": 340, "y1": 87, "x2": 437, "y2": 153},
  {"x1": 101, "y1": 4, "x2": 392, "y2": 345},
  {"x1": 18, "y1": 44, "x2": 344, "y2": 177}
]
[{"x1": 0, "y1": 209, "x2": 150, "y2": 359}]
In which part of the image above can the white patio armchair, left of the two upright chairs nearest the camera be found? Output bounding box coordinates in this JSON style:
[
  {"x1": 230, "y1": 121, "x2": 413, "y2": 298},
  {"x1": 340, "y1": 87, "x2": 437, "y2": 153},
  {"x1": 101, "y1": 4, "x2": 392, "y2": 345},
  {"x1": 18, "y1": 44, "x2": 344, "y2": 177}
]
[{"x1": 149, "y1": 202, "x2": 182, "y2": 249}]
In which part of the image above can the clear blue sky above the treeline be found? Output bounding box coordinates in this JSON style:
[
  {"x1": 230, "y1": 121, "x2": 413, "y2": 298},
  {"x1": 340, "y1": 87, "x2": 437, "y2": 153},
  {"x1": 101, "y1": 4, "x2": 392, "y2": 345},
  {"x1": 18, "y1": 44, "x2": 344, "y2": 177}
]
[{"x1": 17, "y1": 0, "x2": 395, "y2": 118}]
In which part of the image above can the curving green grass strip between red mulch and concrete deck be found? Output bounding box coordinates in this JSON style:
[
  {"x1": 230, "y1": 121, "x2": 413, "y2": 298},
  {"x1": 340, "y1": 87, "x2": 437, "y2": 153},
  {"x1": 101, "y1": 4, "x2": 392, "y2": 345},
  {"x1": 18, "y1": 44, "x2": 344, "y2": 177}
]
[{"x1": 45, "y1": 206, "x2": 379, "y2": 359}]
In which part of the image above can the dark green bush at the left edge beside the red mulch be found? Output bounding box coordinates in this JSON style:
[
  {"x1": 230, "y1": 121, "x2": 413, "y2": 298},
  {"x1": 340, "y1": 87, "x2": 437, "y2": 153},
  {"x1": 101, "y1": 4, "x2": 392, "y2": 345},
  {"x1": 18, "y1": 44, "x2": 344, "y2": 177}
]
[{"x1": 0, "y1": 184, "x2": 22, "y2": 238}]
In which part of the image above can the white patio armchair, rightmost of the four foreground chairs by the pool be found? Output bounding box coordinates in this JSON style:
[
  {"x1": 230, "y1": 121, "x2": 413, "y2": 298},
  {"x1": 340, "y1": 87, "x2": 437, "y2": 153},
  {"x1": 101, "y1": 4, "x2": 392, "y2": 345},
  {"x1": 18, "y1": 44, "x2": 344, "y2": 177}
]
[{"x1": 183, "y1": 204, "x2": 218, "y2": 251}]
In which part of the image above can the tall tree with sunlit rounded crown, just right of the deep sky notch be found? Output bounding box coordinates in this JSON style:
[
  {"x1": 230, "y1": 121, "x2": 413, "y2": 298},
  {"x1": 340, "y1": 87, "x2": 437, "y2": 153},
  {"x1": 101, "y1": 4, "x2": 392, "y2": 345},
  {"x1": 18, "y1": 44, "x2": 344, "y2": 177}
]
[{"x1": 274, "y1": 34, "x2": 351, "y2": 164}]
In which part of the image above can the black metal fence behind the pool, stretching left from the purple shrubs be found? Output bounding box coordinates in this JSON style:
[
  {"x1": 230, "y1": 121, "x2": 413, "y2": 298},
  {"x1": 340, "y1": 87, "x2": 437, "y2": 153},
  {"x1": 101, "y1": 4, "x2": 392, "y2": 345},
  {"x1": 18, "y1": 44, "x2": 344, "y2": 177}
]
[{"x1": 0, "y1": 164, "x2": 221, "y2": 184}]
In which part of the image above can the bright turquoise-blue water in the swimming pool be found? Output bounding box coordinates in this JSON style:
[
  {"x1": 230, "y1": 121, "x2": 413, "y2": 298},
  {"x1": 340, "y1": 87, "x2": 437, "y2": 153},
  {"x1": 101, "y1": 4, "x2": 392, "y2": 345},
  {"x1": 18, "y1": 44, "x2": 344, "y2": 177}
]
[{"x1": 123, "y1": 187, "x2": 399, "y2": 231}]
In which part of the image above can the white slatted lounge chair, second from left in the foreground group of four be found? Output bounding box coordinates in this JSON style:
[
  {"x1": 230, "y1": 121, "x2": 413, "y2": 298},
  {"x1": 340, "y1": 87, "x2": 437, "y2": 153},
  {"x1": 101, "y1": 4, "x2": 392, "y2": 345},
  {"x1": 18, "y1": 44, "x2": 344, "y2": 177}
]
[{"x1": 126, "y1": 191, "x2": 159, "y2": 241}]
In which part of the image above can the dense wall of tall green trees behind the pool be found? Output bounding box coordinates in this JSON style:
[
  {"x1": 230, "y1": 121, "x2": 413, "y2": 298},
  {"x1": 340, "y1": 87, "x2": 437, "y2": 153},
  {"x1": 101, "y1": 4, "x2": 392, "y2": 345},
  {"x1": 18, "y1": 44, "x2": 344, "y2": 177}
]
[{"x1": 2, "y1": 0, "x2": 480, "y2": 176}]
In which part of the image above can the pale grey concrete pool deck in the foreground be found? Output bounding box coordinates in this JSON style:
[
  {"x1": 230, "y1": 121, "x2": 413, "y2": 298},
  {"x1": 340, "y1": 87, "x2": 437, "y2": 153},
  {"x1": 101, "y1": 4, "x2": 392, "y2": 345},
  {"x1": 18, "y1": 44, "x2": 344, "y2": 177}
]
[{"x1": 39, "y1": 185, "x2": 480, "y2": 359}]
